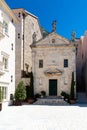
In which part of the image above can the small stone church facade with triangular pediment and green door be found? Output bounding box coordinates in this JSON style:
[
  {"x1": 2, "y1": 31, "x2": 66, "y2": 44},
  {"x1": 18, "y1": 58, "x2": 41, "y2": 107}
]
[{"x1": 31, "y1": 32, "x2": 76, "y2": 96}]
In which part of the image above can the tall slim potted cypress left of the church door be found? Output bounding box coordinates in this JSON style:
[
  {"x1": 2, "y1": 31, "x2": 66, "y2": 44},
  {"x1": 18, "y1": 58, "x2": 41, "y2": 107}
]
[{"x1": 28, "y1": 72, "x2": 34, "y2": 104}]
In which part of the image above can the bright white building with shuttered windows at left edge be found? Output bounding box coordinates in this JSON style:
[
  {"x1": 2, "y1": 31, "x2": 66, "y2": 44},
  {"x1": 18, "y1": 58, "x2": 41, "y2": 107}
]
[{"x1": 0, "y1": 0, "x2": 18, "y2": 105}]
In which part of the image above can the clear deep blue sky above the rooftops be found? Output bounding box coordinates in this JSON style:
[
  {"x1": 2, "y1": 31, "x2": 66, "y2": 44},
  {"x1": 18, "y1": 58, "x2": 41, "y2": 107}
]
[{"x1": 5, "y1": 0, "x2": 87, "y2": 39}]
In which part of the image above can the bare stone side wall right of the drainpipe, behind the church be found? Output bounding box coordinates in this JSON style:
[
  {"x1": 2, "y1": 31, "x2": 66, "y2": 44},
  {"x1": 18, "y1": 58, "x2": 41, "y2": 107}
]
[{"x1": 24, "y1": 15, "x2": 42, "y2": 72}]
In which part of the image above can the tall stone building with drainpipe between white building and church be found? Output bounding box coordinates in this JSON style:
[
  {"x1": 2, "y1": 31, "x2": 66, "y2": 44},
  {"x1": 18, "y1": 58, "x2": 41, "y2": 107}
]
[{"x1": 13, "y1": 8, "x2": 42, "y2": 86}]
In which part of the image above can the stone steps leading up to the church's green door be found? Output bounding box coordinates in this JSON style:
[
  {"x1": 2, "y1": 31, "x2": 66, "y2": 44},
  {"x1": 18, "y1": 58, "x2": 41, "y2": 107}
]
[{"x1": 34, "y1": 98, "x2": 68, "y2": 105}]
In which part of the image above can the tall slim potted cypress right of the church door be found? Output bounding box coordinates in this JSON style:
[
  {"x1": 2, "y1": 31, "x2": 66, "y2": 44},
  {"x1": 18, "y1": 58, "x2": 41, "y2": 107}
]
[{"x1": 69, "y1": 72, "x2": 75, "y2": 104}]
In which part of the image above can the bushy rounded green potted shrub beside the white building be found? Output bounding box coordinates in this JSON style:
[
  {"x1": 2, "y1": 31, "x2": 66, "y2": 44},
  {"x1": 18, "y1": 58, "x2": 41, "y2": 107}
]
[{"x1": 15, "y1": 81, "x2": 26, "y2": 105}]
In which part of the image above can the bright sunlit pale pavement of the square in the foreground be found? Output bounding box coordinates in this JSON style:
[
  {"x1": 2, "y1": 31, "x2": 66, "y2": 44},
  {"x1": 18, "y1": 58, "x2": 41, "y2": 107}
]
[{"x1": 0, "y1": 104, "x2": 87, "y2": 130}]
